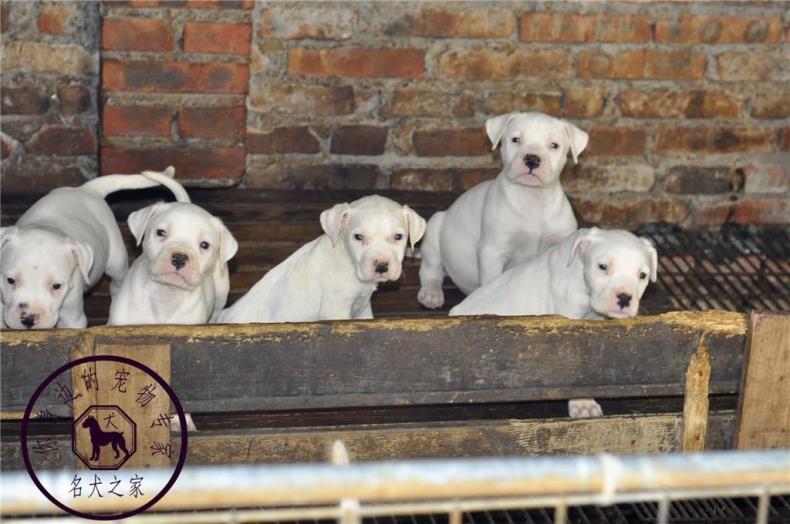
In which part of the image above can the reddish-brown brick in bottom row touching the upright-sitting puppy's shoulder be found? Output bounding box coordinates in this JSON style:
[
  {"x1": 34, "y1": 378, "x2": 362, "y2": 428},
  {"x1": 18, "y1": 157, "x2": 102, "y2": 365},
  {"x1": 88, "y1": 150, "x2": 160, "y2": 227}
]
[{"x1": 571, "y1": 195, "x2": 689, "y2": 228}]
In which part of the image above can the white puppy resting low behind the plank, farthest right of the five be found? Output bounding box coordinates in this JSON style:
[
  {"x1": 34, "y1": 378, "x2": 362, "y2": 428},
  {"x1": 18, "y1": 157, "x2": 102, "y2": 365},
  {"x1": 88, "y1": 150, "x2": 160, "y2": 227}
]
[{"x1": 450, "y1": 228, "x2": 658, "y2": 417}]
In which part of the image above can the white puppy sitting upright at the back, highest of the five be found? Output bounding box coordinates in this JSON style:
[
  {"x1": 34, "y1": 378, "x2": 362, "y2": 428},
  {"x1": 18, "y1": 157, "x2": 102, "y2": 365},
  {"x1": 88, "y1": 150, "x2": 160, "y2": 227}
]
[{"x1": 417, "y1": 113, "x2": 589, "y2": 308}]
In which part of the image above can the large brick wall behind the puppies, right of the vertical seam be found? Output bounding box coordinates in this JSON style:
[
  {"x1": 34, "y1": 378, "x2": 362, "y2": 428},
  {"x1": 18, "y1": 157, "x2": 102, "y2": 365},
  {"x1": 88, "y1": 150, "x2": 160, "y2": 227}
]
[{"x1": 3, "y1": 0, "x2": 790, "y2": 225}]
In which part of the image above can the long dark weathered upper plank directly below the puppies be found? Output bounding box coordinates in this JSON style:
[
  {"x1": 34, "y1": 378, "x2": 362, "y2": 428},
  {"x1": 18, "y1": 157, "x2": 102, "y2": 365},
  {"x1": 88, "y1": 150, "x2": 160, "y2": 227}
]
[{"x1": 3, "y1": 312, "x2": 746, "y2": 413}]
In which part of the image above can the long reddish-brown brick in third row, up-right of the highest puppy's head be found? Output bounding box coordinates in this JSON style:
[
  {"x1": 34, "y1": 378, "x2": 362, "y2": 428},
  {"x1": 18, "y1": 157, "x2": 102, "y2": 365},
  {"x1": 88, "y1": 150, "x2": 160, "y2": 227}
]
[{"x1": 619, "y1": 89, "x2": 743, "y2": 118}]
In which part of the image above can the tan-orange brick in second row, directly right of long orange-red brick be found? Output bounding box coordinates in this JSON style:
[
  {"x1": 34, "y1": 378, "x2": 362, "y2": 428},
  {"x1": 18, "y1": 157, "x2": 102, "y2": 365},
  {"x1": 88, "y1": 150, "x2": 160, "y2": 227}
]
[{"x1": 439, "y1": 49, "x2": 573, "y2": 80}]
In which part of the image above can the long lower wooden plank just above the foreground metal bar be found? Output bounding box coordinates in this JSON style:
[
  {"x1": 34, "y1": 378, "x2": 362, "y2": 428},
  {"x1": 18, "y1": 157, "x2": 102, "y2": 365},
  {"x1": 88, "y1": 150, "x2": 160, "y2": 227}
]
[{"x1": 2, "y1": 411, "x2": 735, "y2": 469}]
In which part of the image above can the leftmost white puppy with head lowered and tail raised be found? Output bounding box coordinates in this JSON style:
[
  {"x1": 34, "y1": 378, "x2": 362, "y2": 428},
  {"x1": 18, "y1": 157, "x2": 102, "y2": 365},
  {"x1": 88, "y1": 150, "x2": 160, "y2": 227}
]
[{"x1": 0, "y1": 167, "x2": 180, "y2": 329}]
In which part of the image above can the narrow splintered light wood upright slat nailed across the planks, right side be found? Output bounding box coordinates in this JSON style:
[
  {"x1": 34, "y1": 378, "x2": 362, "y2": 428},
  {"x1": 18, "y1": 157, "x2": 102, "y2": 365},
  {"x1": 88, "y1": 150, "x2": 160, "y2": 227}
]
[{"x1": 682, "y1": 335, "x2": 710, "y2": 452}]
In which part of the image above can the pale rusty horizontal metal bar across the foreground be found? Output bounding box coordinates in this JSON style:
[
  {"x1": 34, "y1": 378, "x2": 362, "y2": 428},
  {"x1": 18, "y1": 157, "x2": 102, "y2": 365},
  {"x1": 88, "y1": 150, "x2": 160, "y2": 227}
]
[{"x1": 0, "y1": 450, "x2": 790, "y2": 516}]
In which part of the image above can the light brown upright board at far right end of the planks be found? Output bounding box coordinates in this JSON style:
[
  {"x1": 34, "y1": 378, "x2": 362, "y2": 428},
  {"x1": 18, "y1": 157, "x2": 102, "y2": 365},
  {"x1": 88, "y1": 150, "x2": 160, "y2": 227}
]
[{"x1": 736, "y1": 313, "x2": 790, "y2": 449}]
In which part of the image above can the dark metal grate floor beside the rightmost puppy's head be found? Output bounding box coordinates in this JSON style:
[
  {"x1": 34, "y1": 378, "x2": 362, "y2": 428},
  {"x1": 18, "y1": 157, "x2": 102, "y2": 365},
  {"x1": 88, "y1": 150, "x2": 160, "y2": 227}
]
[{"x1": 636, "y1": 224, "x2": 790, "y2": 313}]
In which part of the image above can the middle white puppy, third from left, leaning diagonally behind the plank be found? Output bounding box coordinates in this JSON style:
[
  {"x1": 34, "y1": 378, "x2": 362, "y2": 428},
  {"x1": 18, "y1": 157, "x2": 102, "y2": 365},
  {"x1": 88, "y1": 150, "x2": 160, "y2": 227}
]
[{"x1": 218, "y1": 195, "x2": 425, "y2": 323}]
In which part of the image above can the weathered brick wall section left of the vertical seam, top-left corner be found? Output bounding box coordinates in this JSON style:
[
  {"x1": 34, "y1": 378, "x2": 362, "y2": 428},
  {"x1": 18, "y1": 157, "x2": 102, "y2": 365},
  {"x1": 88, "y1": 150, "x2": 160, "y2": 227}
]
[{"x1": 0, "y1": 1, "x2": 100, "y2": 193}]
